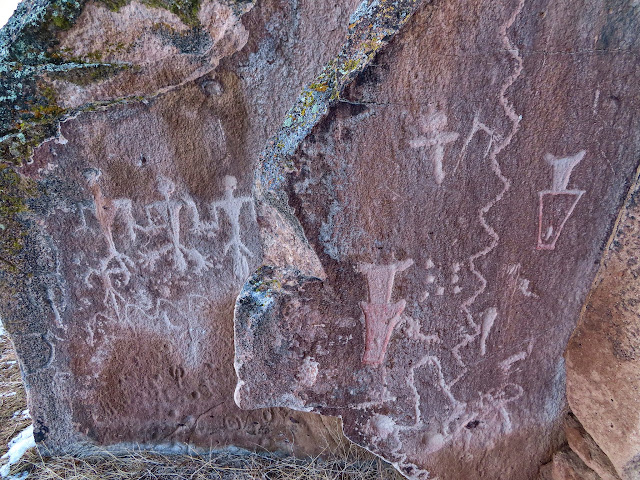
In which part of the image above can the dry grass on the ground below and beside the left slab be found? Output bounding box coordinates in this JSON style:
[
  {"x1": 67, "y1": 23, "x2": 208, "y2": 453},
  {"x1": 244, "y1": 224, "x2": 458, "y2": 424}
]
[{"x1": 0, "y1": 335, "x2": 403, "y2": 480}]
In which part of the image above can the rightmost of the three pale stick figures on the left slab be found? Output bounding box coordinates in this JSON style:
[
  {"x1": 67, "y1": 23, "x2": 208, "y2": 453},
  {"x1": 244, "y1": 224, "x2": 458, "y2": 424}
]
[{"x1": 209, "y1": 175, "x2": 256, "y2": 280}]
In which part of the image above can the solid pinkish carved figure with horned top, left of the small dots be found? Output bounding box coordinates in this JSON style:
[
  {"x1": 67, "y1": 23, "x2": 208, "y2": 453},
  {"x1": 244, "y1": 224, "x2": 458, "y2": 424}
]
[{"x1": 358, "y1": 259, "x2": 413, "y2": 366}]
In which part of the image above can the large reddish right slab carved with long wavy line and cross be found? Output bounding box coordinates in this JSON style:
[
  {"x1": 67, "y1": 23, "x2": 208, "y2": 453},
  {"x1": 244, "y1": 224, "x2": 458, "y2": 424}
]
[{"x1": 235, "y1": 0, "x2": 640, "y2": 480}]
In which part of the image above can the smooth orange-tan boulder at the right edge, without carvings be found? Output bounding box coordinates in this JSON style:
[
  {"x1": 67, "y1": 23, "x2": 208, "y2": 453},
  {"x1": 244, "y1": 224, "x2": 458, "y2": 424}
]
[{"x1": 565, "y1": 163, "x2": 640, "y2": 480}]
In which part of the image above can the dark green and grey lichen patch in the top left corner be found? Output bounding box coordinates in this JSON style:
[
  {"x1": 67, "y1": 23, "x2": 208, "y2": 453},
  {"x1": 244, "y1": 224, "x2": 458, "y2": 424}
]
[{"x1": 0, "y1": 0, "x2": 140, "y2": 165}]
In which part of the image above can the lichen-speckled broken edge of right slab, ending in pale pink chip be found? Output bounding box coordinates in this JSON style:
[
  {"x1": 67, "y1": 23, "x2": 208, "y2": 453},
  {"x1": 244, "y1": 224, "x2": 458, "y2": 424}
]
[{"x1": 254, "y1": 0, "x2": 432, "y2": 278}]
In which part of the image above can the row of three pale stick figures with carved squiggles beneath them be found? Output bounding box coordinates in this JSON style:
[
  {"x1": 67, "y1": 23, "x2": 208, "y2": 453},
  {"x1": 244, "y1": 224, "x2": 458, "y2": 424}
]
[{"x1": 77, "y1": 169, "x2": 255, "y2": 364}]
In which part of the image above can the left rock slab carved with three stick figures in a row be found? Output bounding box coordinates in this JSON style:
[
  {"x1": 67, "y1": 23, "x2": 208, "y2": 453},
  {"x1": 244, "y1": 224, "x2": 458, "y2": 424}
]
[{"x1": 0, "y1": 0, "x2": 364, "y2": 454}]
